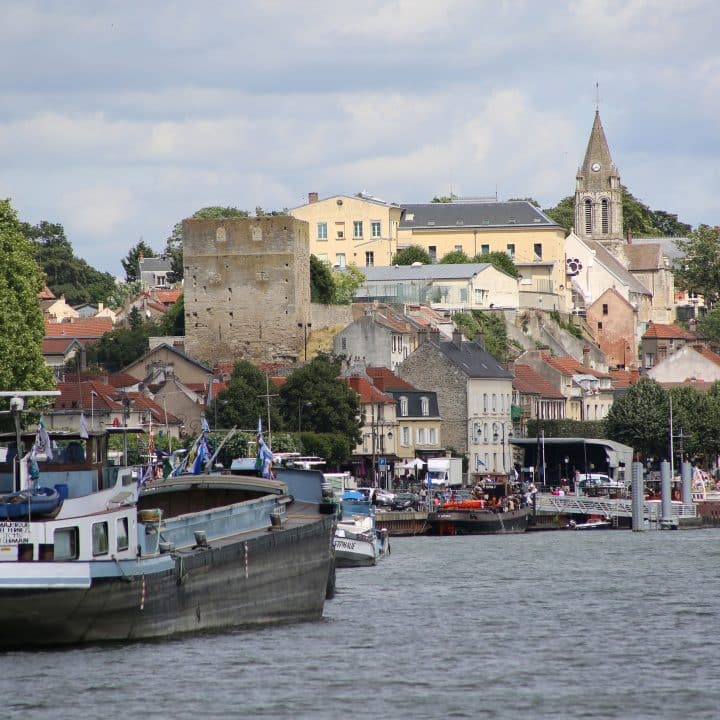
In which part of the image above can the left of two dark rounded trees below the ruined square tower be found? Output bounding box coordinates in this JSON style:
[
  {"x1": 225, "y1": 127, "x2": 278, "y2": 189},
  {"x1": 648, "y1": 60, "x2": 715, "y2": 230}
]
[{"x1": 212, "y1": 360, "x2": 282, "y2": 431}]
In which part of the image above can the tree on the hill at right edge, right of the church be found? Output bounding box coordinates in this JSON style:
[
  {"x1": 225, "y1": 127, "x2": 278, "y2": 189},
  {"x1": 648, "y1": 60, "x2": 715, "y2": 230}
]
[{"x1": 673, "y1": 225, "x2": 720, "y2": 308}]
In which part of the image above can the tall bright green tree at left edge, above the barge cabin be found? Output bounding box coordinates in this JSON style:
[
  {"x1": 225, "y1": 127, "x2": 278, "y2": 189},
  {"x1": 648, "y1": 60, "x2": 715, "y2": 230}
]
[{"x1": 0, "y1": 200, "x2": 55, "y2": 390}]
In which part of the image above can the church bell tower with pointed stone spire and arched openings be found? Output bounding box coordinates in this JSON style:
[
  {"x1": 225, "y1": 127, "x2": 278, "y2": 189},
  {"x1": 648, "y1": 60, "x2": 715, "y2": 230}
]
[{"x1": 575, "y1": 110, "x2": 624, "y2": 252}]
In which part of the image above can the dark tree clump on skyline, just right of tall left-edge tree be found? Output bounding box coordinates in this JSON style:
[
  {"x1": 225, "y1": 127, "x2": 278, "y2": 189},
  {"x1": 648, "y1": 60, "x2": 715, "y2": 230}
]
[{"x1": 20, "y1": 220, "x2": 115, "y2": 305}]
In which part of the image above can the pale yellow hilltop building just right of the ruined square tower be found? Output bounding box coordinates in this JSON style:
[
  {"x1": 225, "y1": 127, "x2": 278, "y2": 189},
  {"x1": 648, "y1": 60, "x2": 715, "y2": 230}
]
[{"x1": 290, "y1": 193, "x2": 402, "y2": 268}]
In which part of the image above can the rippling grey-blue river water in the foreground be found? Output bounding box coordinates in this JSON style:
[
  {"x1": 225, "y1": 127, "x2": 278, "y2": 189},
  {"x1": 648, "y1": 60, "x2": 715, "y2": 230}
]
[{"x1": 0, "y1": 529, "x2": 720, "y2": 720}]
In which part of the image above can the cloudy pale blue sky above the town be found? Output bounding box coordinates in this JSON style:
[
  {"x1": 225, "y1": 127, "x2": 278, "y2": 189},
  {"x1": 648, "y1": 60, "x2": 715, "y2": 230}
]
[{"x1": 0, "y1": 0, "x2": 720, "y2": 275}]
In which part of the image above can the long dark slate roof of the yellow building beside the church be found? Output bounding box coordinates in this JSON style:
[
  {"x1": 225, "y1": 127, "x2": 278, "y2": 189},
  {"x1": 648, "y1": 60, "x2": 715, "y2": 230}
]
[{"x1": 400, "y1": 200, "x2": 560, "y2": 229}]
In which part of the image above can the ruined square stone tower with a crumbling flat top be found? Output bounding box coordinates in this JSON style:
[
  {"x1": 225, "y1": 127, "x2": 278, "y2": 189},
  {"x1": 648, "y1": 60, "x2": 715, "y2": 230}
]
[{"x1": 183, "y1": 215, "x2": 310, "y2": 365}]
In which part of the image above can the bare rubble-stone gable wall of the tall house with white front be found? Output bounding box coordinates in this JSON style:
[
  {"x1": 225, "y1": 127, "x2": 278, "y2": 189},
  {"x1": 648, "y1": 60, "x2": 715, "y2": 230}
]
[{"x1": 395, "y1": 338, "x2": 468, "y2": 453}]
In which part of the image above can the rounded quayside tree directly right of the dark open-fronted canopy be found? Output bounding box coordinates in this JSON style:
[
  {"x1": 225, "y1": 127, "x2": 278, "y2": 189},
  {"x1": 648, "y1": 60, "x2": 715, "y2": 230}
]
[{"x1": 605, "y1": 377, "x2": 670, "y2": 458}]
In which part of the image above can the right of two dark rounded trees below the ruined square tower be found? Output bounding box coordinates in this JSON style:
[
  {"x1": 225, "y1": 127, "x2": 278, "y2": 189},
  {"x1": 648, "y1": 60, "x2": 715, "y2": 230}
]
[{"x1": 279, "y1": 354, "x2": 360, "y2": 446}]
